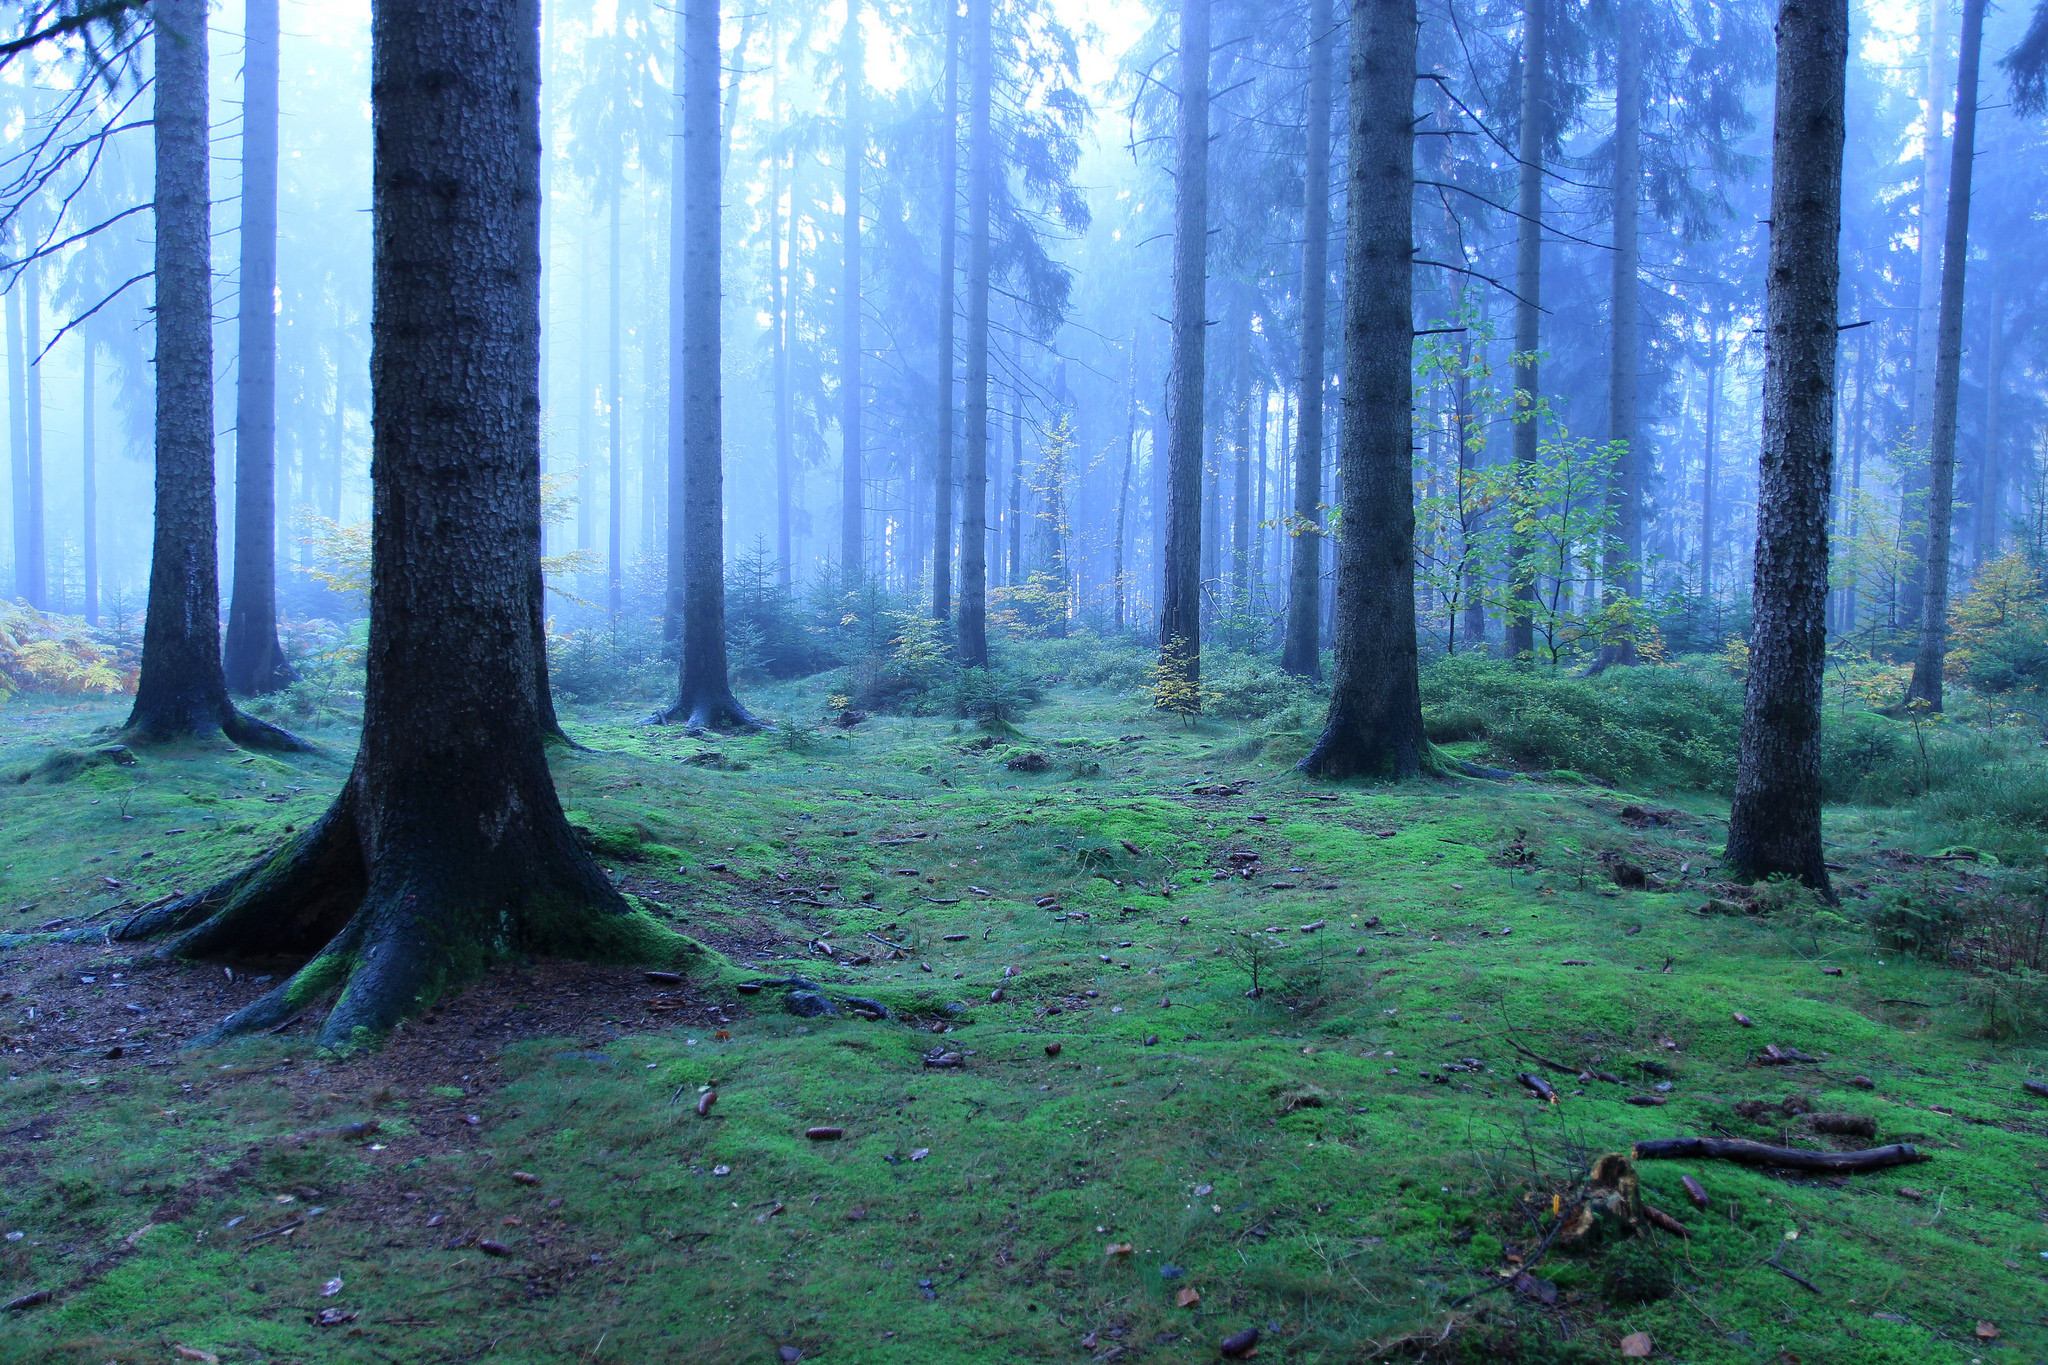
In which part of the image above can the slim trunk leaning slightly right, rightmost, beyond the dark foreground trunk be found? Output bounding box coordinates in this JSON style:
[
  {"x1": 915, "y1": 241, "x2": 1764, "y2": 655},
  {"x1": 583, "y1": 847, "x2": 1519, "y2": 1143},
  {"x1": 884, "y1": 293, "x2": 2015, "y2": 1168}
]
[{"x1": 1896, "y1": 0, "x2": 1949, "y2": 626}]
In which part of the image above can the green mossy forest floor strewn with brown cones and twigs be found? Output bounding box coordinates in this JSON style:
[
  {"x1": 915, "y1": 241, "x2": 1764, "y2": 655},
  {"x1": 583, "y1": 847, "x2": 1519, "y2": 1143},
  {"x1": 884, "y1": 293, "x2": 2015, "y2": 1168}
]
[{"x1": 0, "y1": 688, "x2": 2048, "y2": 1365}]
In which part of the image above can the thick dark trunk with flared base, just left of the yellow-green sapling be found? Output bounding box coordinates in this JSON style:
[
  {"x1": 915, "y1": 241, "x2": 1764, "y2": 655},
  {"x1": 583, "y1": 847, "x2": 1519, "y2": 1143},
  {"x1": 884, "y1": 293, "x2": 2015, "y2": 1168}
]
[{"x1": 1300, "y1": 0, "x2": 1427, "y2": 778}]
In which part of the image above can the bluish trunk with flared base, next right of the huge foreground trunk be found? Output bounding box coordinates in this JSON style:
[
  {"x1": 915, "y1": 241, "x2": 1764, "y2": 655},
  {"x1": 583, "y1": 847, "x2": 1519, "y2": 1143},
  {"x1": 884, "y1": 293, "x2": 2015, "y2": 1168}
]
[{"x1": 659, "y1": 0, "x2": 758, "y2": 731}]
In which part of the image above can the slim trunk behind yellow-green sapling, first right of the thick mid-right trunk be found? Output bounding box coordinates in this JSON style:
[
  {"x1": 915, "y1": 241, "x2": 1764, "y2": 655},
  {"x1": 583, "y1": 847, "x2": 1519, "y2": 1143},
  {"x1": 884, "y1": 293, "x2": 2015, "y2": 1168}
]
[{"x1": 1505, "y1": 0, "x2": 1548, "y2": 659}]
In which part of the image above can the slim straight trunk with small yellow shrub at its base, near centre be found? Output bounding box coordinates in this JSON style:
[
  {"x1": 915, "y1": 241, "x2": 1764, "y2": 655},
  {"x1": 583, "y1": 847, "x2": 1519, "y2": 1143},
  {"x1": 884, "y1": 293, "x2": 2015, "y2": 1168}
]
[{"x1": 1159, "y1": 0, "x2": 1208, "y2": 708}]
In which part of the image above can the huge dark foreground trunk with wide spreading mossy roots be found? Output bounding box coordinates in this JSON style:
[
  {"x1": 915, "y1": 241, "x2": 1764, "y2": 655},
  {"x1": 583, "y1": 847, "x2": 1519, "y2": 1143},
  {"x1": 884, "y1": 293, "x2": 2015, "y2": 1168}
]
[{"x1": 115, "y1": 0, "x2": 688, "y2": 1052}]
